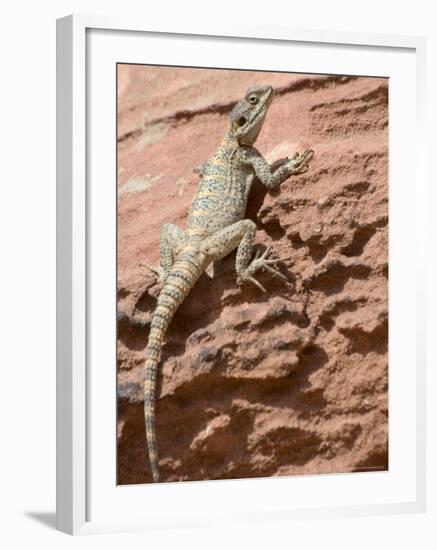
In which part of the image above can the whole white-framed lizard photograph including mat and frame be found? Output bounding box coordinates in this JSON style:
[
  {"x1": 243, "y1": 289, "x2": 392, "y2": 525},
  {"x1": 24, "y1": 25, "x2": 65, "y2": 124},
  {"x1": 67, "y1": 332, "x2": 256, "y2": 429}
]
[{"x1": 57, "y1": 16, "x2": 426, "y2": 534}]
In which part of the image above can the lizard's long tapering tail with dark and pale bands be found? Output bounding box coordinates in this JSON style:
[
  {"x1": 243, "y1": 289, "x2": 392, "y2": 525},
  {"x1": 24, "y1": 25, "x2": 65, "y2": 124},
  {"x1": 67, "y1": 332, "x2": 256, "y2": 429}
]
[{"x1": 144, "y1": 250, "x2": 206, "y2": 482}]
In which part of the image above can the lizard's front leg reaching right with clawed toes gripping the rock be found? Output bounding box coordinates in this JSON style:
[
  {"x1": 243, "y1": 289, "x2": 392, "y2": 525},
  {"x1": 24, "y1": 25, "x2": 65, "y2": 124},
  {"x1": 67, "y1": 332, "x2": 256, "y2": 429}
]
[{"x1": 242, "y1": 147, "x2": 314, "y2": 189}]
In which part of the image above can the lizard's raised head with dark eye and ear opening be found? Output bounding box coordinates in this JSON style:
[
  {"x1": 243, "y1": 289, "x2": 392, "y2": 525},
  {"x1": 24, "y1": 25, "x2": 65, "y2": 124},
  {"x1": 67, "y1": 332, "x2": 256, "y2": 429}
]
[{"x1": 231, "y1": 86, "x2": 273, "y2": 145}]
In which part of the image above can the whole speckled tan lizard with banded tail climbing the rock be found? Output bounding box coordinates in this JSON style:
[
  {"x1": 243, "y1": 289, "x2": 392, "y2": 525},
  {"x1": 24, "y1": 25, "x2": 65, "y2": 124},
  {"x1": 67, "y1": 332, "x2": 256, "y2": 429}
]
[{"x1": 144, "y1": 86, "x2": 313, "y2": 482}]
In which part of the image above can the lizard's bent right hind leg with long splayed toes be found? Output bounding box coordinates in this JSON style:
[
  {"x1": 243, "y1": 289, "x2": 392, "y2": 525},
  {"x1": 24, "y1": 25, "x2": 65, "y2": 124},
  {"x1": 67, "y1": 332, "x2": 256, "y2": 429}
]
[{"x1": 200, "y1": 220, "x2": 286, "y2": 292}]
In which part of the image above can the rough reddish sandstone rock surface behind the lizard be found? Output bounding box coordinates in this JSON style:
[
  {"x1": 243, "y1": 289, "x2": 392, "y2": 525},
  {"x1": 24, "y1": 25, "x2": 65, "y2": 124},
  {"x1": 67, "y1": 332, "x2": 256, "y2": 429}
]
[{"x1": 118, "y1": 65, "x2": 388, "y2": 484}]
